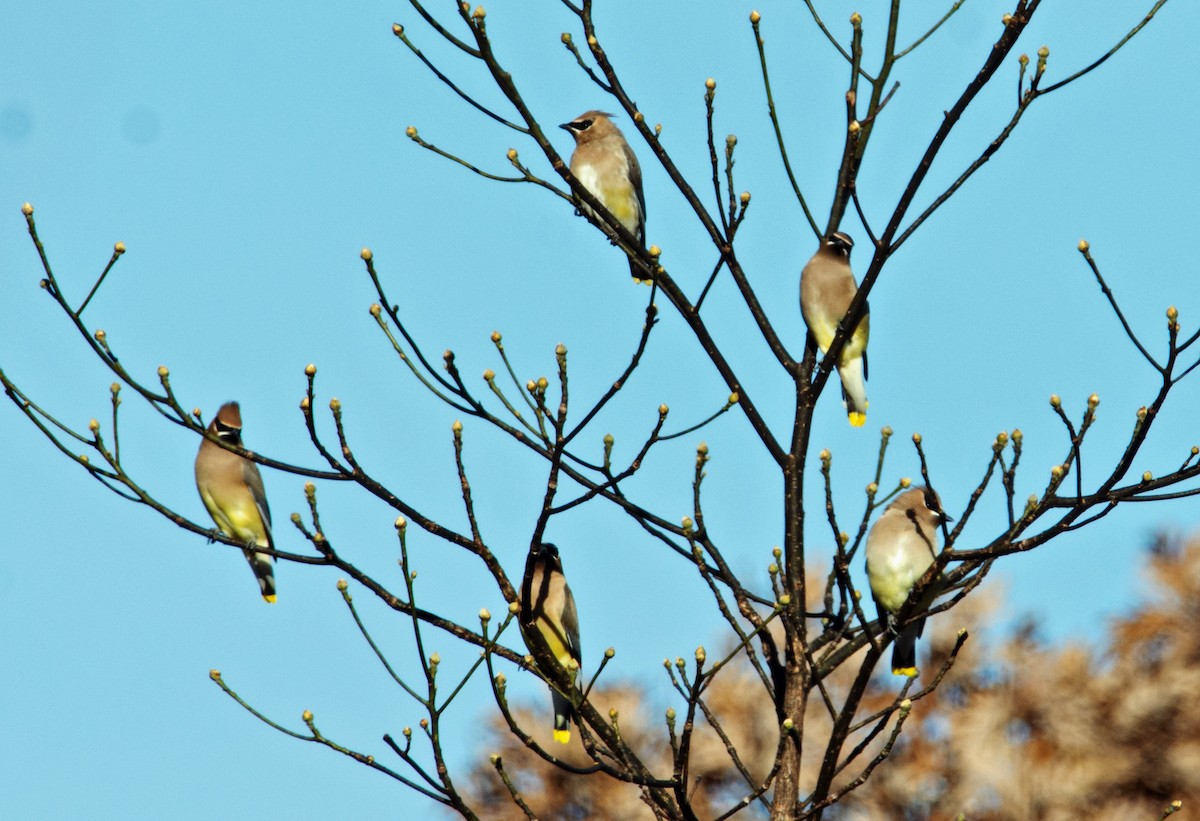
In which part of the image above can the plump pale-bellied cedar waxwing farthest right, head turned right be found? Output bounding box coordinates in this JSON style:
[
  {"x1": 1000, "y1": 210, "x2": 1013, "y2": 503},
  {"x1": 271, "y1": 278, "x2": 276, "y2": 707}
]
[{"x1": 866, "y1": 487, "x2": 952, "y2": 676}]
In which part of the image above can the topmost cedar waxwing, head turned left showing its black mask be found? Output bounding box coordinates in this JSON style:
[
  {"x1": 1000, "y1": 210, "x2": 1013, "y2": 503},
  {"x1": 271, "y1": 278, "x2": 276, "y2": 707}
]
[{"x1": 559, "y1": 112, "x2": 647, "y2": 282}]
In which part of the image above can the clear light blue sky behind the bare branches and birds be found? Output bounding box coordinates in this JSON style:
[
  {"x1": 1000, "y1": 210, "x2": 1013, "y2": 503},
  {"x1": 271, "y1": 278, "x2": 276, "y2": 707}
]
[{"x1": 0, "y1": 0, "x2": 1200, "y2": 819}]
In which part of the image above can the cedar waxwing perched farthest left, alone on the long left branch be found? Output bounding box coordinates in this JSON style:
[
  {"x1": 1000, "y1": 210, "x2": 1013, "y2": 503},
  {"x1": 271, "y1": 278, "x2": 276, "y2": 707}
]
[{"x1": 196, "y1": 402, "x2": 275, "y2": 604}]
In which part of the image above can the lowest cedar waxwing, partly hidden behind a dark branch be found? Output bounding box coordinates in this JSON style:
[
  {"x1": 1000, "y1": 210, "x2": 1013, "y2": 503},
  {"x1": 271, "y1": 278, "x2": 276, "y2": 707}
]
[{"x1": 520, "y1": 544, "x2": 580, "y2": 744}]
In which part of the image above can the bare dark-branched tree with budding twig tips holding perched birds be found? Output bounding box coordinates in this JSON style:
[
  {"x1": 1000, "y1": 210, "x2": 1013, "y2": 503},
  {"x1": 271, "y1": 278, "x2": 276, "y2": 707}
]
[{"x1": 0, "y1": 0, "x2": 1185, "y2": 819}]
